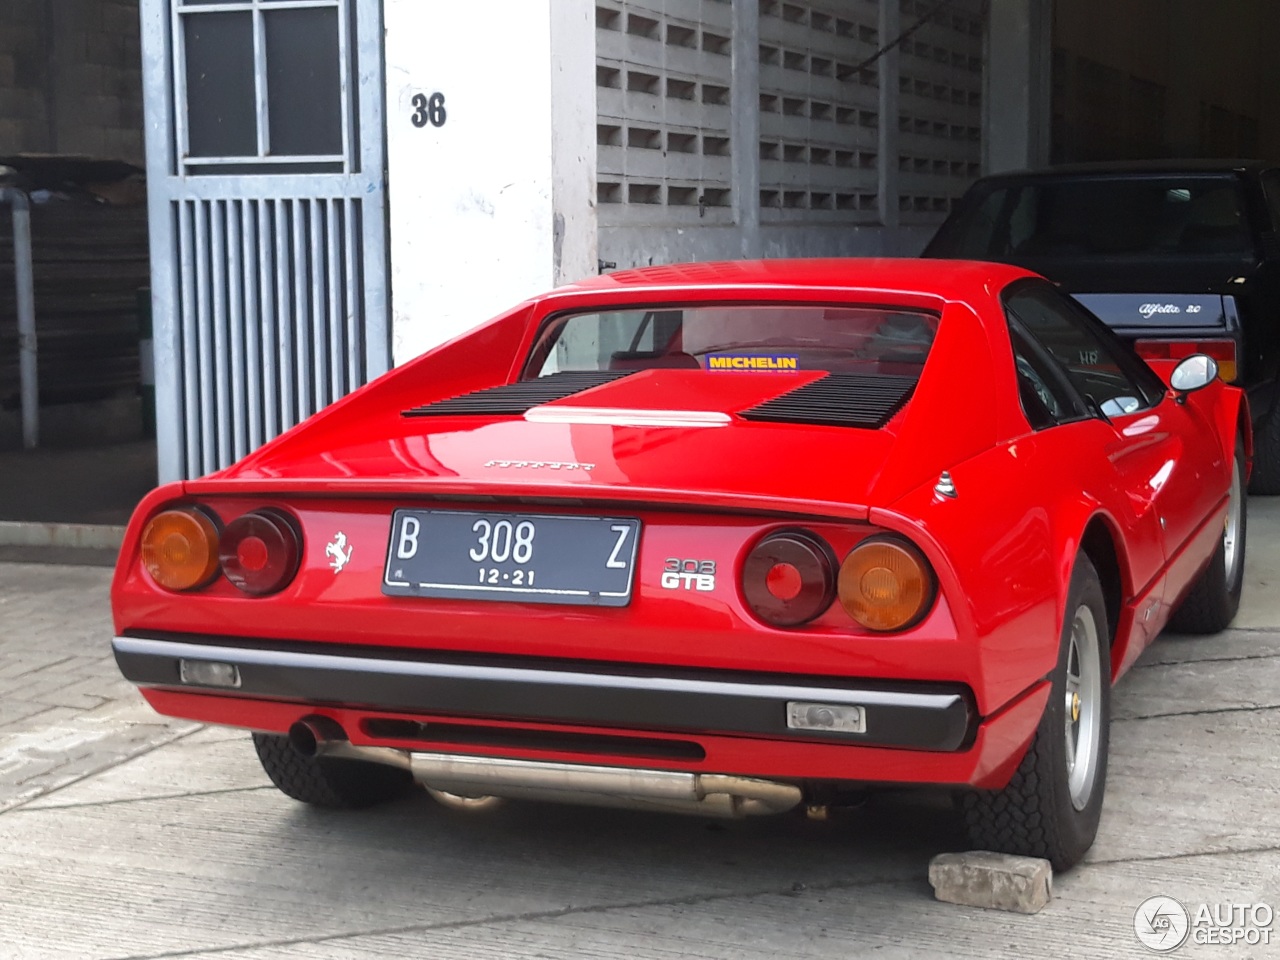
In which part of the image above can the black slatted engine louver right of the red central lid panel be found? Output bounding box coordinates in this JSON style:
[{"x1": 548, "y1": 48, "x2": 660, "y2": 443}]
[{"x1": 739, "y1": 374, "x2": 916, "y2": 429}]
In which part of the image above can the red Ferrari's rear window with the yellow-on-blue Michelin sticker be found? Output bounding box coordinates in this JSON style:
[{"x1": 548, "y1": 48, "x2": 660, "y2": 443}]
[{"x1": 525, "y1": 305, "x2": 938, "y2": 378}]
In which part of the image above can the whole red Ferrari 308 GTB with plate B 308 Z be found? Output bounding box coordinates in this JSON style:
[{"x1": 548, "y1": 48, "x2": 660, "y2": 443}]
[{"x1": 113, "y1": 260, "x2": 1251, "y2": 869}]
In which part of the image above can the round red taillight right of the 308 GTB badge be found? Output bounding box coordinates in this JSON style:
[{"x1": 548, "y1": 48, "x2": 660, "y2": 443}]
[{"x1": 742, "y1": 530, "x2": 836, "y2": 627}]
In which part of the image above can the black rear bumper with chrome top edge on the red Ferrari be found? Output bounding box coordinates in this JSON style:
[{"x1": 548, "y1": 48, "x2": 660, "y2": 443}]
[{"x1": 111, "y1": 637, "x2": 974, "y2": 751}]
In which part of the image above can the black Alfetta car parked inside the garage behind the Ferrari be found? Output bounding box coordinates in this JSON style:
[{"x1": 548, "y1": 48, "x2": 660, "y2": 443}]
[{"x1": 924, "y1": 160, "x2": 1280, "y2": 494}]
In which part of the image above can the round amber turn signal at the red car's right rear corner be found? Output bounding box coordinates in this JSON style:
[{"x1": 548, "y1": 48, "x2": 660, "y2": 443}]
[{"x1": 836, "y1": 539, "x2": 934, "y2": 631}]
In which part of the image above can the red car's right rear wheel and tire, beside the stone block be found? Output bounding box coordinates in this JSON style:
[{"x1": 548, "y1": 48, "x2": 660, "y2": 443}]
[{"x1": 963, "y1": 554, "x2": 1111, "y2": 870}]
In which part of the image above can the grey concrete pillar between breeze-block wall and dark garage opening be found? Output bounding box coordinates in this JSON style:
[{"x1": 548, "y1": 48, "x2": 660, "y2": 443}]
[{"x1": 982, "y1": 0, "x2": 1053, "y2": 173}]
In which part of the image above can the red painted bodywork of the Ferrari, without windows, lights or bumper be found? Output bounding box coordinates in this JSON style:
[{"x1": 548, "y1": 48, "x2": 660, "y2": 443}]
[{"x1": 113, "y1": 260, "x2": 1249, "y2": 787}]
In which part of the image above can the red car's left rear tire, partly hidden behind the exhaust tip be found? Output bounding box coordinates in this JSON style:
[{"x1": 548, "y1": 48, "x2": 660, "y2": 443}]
[{"x1": 253, "y1": 733, "x2": 413, "y2": 809}]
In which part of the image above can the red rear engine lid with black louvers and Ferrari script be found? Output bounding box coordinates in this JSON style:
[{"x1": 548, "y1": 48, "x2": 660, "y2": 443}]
[{"x1": 188, "y1": 370, "x2": 915, "y2": 517}]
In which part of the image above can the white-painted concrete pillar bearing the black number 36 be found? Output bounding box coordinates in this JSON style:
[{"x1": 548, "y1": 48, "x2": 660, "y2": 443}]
[{"x1": 383, "y1": 0, "x2": 596, "y2": 364}]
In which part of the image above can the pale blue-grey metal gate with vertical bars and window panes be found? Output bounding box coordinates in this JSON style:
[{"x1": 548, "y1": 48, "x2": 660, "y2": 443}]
[{"x1": 141, "y1": 0, "x2": 390, "y2": 481}]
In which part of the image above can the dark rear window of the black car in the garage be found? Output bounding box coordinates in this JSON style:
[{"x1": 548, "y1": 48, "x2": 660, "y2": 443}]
[{"x1": 929, "y1": 177, "x2": 1252, "y2": 262}]
